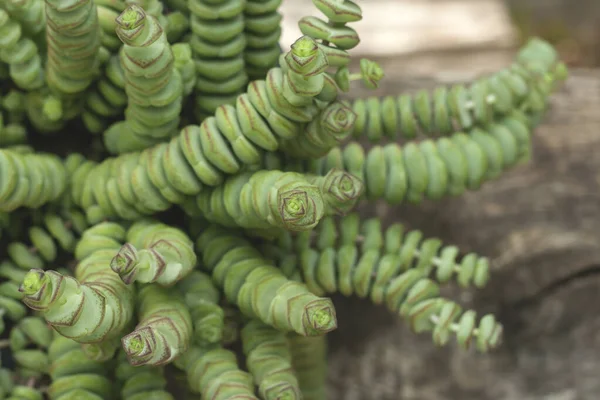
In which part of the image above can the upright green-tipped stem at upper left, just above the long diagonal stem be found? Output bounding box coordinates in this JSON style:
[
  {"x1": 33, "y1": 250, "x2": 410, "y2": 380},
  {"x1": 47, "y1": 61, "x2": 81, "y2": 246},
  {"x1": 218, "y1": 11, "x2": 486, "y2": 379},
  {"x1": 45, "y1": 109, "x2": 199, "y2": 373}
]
[{"x1": 104, "y1": 4, "x2": 183, "y2": 153}]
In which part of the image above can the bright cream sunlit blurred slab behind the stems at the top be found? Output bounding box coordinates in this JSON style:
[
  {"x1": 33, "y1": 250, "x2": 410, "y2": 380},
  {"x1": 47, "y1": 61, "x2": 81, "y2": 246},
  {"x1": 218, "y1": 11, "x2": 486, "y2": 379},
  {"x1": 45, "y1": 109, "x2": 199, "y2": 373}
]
[{"x1": 281, "y1": 0, "x2": 515, "y2": 56}]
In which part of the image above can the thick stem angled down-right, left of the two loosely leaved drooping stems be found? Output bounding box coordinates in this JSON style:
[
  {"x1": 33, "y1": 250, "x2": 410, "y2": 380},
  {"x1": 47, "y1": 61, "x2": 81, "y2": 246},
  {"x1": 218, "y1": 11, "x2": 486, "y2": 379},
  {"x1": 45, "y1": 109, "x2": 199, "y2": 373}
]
[{"x1": 196, "y1": 226, "x2": 337, "y2": 336}]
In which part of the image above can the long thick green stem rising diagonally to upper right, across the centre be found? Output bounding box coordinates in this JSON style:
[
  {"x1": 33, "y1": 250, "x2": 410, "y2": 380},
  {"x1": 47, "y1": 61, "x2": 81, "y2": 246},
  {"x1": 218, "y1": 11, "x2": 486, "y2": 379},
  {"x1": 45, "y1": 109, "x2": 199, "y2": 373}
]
[{"x1": 67, "y1": 35, "x2": 344, "y2": 222}]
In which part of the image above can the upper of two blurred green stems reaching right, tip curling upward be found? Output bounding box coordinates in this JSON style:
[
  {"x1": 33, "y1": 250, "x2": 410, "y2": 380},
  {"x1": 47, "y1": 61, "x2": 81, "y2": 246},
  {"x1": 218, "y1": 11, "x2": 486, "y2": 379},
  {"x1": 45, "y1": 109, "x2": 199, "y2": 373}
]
[{"x1": 352, "y1": 39, "x2": 565, "y2": 142}]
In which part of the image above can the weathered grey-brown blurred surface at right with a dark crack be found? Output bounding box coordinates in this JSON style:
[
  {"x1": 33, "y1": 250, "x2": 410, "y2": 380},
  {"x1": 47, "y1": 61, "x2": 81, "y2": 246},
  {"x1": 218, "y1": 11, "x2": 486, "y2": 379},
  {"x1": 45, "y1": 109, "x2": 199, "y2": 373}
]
[{"x1": 328, "y1": 70, "x2": 600, "y2": 400}]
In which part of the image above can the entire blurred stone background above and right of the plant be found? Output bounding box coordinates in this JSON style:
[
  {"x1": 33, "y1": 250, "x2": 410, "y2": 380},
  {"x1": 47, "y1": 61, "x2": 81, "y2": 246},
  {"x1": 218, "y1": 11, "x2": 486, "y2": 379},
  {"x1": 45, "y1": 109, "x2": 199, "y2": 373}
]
[{"x1": 282, "y1": 0, "x2": 600, "y2": 400}]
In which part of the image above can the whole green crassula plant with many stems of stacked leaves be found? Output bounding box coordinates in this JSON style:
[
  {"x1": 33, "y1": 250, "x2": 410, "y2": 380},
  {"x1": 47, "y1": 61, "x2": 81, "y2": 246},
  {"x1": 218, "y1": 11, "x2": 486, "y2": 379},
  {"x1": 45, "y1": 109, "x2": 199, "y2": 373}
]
[{"x1": 0, "y1": 0, "x2": 566, "y2": 400}]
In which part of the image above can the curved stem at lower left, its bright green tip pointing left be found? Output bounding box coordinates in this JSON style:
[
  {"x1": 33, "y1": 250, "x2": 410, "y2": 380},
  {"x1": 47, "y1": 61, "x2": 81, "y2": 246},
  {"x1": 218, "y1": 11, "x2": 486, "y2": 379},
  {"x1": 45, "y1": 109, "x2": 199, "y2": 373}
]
[{"x1": 19, "y1": 222, "x2": 134, "y2": 343}]
